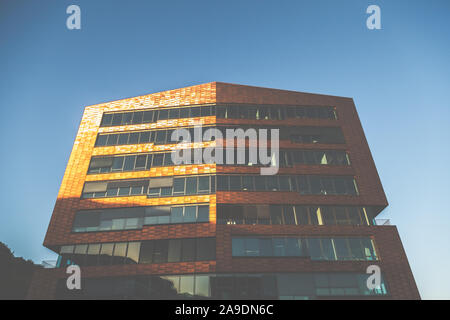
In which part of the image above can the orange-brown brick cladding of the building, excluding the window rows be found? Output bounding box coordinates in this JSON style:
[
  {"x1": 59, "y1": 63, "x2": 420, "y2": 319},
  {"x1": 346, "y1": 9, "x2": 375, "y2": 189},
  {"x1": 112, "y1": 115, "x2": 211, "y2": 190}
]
[{"x1": 29, "y1": 82, "x2": 420, "y2": 299}]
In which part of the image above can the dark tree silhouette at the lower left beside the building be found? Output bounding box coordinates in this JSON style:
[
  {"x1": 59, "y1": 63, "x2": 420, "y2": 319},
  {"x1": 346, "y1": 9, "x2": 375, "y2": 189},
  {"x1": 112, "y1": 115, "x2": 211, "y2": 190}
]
[{"x1": 0, "y1": 242, "x2": 41, "y2": 299}]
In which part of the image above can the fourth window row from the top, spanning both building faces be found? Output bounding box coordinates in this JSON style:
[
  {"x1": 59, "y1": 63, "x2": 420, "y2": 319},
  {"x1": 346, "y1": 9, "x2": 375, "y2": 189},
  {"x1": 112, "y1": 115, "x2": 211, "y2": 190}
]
[{"x1": 82, "y1": 175, "x2": 358, "y2": 198}]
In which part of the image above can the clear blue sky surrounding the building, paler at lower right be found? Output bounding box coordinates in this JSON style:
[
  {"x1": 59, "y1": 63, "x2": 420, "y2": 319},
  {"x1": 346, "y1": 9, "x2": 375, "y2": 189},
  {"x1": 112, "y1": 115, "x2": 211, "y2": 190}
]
[{"x1": 0, "y1": 0, "x2": 450, "y2": 299}]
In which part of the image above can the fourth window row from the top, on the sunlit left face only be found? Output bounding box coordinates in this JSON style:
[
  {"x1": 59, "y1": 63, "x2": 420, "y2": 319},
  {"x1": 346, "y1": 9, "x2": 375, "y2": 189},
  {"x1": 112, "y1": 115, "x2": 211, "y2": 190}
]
[{"x1": 82, "y1": 176, "x2": 216, "y2": 198}]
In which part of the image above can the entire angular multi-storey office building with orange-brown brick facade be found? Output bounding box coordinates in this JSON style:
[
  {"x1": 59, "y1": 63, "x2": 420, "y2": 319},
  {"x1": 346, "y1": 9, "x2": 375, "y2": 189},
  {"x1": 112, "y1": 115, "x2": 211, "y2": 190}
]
[{"x1": 29, "y1": 82, "x2": 420, "y2": 299}]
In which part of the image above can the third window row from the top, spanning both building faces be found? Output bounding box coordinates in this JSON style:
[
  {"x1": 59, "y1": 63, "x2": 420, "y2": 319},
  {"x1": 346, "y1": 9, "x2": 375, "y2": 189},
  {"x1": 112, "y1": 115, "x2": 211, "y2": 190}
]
[{"x1": 88, "y1": 149, "x2": 350, "y2": 174}]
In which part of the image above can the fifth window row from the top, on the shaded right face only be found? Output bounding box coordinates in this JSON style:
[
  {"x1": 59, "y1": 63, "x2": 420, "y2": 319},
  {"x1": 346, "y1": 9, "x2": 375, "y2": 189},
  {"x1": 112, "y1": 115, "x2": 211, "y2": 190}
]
[{"x1": 217, "y1": 204, "x2": 372, "y2": 226}]
